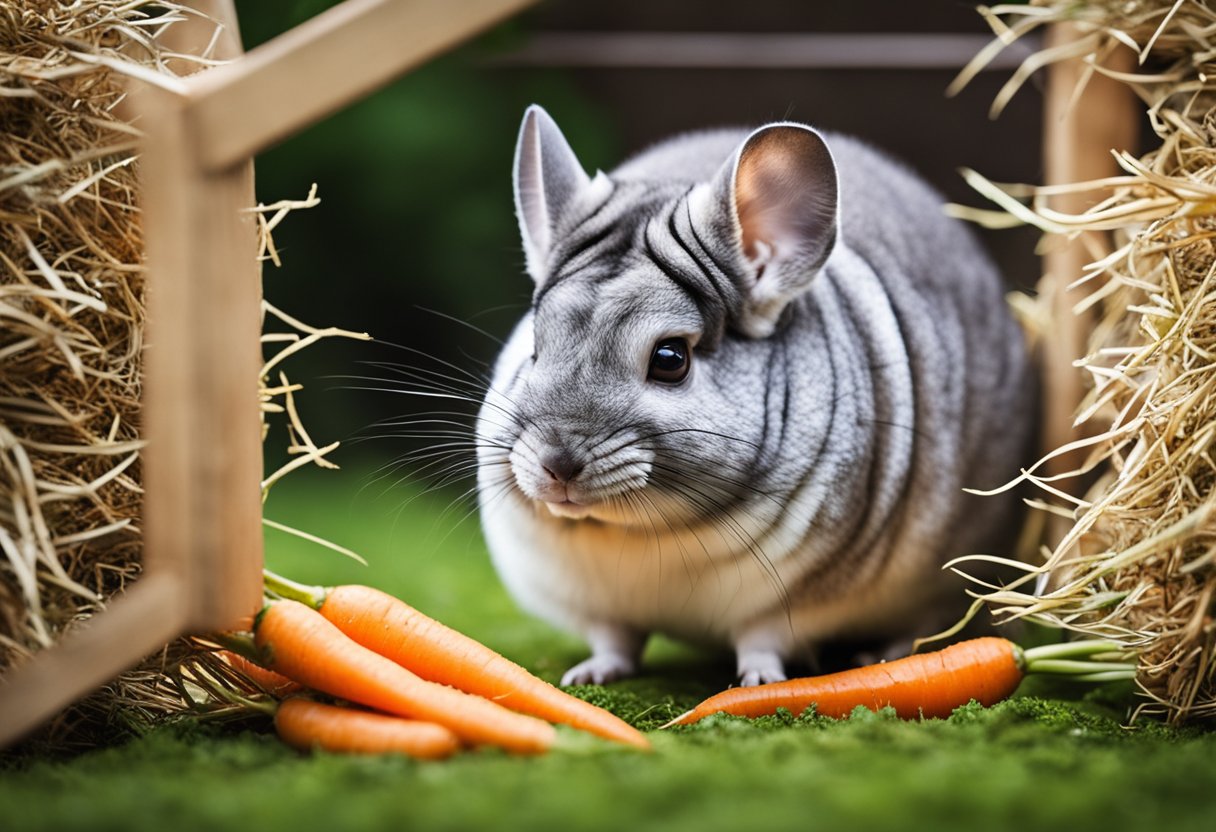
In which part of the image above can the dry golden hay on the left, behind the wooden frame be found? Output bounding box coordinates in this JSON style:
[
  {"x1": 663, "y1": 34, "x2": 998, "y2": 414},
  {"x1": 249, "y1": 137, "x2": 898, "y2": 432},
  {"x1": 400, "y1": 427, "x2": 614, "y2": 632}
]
[{"x1": 0, "y1": 0, "x2": 366, "y2": 744}]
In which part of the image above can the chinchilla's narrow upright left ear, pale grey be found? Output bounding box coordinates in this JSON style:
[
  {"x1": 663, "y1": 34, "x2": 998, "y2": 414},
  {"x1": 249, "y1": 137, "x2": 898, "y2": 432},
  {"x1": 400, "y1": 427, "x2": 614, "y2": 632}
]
[{"x1": 514, "y1": 105, "x2": 591, "y2": 283}]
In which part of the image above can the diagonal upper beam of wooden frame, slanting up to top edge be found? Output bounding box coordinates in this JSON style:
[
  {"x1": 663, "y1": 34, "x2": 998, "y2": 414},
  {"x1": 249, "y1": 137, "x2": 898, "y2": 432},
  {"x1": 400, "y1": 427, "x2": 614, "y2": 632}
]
[{"x1": 188, "y1": 0, "x2": 534, "y2": 170}]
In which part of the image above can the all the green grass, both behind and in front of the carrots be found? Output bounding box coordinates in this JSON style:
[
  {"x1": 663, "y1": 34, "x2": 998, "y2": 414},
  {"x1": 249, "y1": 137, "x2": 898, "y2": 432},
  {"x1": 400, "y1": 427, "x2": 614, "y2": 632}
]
[{"x1": 0, "y1": 462, "x2": 1216, "y2": 832}]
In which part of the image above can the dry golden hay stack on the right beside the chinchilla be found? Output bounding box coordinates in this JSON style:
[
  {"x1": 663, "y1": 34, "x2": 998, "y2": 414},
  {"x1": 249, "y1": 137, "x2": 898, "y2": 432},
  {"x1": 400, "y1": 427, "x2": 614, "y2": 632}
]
[{"x1": 961, "y1": 0, "x2": 1216, "y2": 723}]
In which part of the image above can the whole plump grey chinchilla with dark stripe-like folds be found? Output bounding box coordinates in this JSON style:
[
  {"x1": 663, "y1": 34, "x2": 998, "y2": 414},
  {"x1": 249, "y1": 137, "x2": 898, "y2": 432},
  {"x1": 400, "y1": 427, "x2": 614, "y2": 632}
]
[{"x1": 478, "y1": 107, "x2": 1036, "y2": 684}]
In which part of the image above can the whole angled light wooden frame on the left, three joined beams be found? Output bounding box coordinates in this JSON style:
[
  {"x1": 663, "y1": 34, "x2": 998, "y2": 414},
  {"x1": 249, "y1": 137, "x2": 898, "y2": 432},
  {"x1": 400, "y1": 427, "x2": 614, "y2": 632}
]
[{"x1": 0, "y1": 0, "x2": 534, "y2": 746}]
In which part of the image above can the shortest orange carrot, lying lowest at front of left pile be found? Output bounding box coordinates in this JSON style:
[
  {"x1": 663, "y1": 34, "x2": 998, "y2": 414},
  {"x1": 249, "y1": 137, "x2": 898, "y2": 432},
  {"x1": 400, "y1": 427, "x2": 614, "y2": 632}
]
[{"x1": 275, "y1": 697, "x2": 460, "y2": 760}]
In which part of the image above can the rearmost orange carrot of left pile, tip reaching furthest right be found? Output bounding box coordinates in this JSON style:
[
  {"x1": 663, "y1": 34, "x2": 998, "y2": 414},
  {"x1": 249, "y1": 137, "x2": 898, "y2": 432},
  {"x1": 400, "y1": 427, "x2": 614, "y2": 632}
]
[{"x1": 320, "y1": 585, "x2": 651, "y2": 751}]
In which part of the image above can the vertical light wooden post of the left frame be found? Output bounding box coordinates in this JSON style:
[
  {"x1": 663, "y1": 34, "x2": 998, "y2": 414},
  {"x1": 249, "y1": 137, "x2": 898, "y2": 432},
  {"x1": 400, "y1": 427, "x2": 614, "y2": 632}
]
[{"x1": 134, "y1": 81, "x2": 263, "y2": 631}]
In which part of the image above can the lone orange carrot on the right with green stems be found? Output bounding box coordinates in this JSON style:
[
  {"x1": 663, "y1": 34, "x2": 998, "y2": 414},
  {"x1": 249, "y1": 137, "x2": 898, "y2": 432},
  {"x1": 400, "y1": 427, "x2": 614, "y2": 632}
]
[{"x1": 663, "y1": 636, "x2": 1136, "y2": 727}]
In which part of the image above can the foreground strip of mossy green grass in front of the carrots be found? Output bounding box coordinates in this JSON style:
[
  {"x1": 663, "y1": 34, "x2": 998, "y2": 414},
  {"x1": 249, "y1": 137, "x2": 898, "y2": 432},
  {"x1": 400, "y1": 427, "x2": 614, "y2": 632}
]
[{"x1": 0, "y1": 699, "x2": 1216, "y2": 832}]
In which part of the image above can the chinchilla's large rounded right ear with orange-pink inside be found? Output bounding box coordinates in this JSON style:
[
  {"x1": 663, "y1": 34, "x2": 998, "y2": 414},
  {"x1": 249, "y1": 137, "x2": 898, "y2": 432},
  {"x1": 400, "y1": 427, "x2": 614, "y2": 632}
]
[{"x1": 711, "y1": 122, "x2": 839, "y2": 338}]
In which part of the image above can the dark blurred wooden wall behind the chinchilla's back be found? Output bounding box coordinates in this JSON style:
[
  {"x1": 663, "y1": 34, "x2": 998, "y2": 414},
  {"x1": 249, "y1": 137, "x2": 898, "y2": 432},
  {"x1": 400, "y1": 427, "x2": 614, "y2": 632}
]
[{"x1": 503, "y1": 0, "x2": 1042, "y2": 286}]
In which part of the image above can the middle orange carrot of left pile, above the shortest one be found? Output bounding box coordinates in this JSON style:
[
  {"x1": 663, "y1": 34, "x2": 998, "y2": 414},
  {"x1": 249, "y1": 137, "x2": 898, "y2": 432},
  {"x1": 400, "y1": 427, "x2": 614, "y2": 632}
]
[{"x1": 254, "y1": 601, "x2": 556, "y2": 754}]
